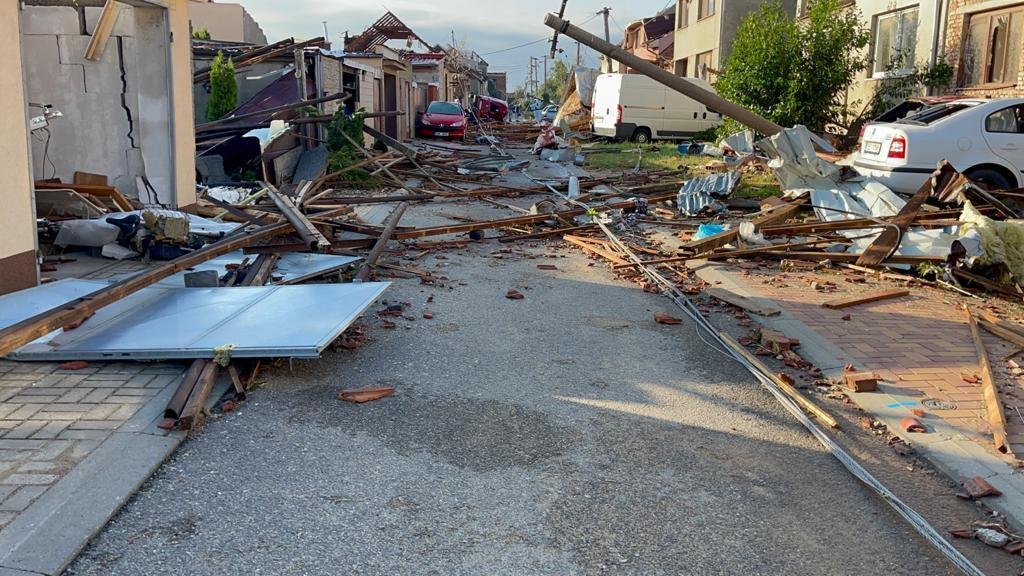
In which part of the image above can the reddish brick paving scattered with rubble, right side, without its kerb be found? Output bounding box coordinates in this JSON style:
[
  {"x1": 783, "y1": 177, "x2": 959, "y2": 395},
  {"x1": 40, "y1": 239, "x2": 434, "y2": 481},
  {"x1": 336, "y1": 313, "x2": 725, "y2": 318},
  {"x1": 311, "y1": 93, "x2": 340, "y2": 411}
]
[{"x1": 729, "y1": 269, "x2": 1024, "y2": 452}]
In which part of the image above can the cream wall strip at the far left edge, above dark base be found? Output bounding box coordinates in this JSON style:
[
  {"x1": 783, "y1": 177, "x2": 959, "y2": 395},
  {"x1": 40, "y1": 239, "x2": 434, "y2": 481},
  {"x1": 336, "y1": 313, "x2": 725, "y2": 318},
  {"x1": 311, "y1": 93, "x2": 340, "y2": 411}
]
[{"x1": 0, "y1": 2, "x2": 36, "y2": 259}]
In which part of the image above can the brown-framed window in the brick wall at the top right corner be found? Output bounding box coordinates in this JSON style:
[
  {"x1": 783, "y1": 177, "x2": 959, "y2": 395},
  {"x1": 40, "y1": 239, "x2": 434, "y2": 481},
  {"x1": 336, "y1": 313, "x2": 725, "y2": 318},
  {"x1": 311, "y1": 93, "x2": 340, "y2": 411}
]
[{"x1": 963, "y1": 8, "x2": 1024, "y2": 86}]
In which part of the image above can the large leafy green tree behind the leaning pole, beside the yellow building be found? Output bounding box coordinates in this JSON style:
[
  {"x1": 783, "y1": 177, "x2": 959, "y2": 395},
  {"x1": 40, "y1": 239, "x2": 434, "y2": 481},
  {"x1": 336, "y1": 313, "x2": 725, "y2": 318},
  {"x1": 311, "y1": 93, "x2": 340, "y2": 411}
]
[{"x1": 716, "y1": 0, "x2": 869, "y2": 131}]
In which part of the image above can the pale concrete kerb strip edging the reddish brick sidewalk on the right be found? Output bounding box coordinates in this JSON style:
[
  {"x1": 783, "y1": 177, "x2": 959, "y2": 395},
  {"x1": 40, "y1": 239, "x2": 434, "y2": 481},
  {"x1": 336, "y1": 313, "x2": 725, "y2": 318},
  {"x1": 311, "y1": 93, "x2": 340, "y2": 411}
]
[{"x1": 689, "y1": 260, "x2": 1024, "y2": 527}]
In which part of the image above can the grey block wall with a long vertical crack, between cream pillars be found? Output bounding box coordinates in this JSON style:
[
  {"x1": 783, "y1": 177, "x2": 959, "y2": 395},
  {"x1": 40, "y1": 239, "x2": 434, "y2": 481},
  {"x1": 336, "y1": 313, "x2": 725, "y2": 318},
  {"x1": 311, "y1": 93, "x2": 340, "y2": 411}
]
[{"x1": 22, "y1": 2, "x2": 174, "y2": 204}]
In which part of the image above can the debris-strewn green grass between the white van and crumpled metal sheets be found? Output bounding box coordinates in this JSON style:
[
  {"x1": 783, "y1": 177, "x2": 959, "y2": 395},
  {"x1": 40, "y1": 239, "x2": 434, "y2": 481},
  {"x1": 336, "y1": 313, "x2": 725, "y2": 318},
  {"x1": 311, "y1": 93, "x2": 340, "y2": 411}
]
[{"x1": 586, "y1": 142, "x2": 780, "y2": 199}]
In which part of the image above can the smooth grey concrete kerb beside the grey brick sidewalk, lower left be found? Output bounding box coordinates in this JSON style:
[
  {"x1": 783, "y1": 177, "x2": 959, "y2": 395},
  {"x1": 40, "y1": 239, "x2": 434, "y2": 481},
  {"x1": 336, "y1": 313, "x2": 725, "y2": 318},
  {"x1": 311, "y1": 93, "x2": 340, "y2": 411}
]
[{"x1": 0, "y1": 368, "x2": 186, "y2": 576}]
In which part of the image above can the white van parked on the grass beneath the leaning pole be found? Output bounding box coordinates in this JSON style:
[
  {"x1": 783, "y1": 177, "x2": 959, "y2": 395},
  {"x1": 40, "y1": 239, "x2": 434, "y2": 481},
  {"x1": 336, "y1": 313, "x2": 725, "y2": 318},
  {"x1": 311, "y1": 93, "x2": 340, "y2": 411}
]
[{"x1": 591, "y1": 74, "x2": 722, "y2": 142}]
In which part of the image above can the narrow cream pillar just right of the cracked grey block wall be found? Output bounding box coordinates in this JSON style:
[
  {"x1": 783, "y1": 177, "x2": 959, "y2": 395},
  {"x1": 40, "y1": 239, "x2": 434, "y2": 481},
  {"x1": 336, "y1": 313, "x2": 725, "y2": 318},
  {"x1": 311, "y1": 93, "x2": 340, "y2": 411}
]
[{"x1": 167, "y1": 0, "x2": 196, "y2": 208}]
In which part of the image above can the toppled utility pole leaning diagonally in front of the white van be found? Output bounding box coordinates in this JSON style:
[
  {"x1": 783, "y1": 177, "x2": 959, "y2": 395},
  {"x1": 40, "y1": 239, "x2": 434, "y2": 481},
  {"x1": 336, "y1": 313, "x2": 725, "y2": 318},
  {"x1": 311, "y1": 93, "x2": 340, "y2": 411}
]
[{"x1": 544, "y1": 14, "x2": 782, "y2": 136}]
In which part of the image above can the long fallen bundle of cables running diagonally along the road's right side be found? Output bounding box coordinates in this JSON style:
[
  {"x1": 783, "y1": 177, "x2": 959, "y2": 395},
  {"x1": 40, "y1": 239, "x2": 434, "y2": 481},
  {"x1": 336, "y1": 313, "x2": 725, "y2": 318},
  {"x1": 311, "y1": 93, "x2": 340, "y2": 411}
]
[{"x1": 523, "y1": 171, "x2": 985, "y2": 576}]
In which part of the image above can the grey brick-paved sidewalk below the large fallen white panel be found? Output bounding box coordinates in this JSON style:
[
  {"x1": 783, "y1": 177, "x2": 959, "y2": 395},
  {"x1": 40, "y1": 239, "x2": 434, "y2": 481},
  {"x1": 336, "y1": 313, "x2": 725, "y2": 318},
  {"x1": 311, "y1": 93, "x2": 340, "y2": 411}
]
[{"x1": 0, "y1": 361, "x2": 182, "y2": 574}]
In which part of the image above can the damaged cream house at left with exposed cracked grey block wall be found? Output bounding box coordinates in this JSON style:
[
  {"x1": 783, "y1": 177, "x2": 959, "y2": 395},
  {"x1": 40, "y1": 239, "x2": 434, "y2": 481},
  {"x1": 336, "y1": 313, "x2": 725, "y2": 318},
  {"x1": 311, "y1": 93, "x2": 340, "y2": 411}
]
[{"x1": 0, "y1": 0, "x2": 196, "y2": 292}]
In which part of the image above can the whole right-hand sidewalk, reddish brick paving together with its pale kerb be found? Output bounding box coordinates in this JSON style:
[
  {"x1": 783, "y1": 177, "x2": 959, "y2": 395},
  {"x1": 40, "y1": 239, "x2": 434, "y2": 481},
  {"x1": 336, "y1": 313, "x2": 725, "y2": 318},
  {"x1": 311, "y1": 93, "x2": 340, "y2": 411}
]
[{"x1": 695, "y1": 258, "x2": 1024, "y2": 526}]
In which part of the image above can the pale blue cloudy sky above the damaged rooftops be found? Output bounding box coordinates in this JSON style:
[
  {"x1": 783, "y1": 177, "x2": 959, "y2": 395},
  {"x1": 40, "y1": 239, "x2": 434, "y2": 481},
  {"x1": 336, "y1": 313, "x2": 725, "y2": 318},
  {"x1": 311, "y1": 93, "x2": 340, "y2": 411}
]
[{"x1": 232, "y1": 0, "x2": 673, "y2": 89}]
